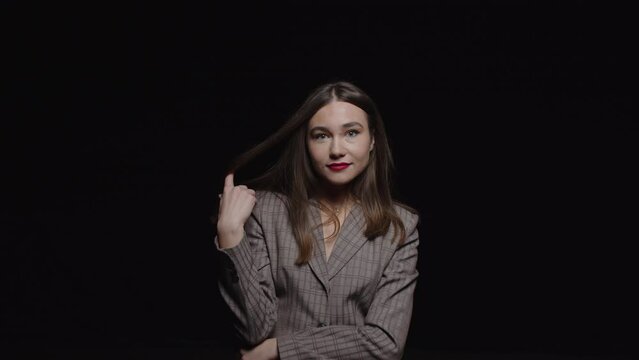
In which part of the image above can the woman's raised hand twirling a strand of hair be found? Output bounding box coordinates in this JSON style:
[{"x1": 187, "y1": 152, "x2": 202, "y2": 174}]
[{"x1": 217, "y1": 173, "x2": 256, "y2": 248}]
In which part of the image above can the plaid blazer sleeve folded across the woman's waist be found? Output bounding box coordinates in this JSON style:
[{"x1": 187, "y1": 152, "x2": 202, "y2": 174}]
[{"x1": 277, "y1": 215, "x2": 419, "y2": 360}]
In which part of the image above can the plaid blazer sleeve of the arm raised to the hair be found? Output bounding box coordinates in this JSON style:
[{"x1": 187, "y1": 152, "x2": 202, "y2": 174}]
[{"x1": 215, "y1": 211, "x2": 277, "y2": 346}]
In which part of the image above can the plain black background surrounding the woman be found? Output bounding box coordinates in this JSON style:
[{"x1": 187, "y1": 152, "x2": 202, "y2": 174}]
[{"x1": 0, "y1": 1, "x2": 639, "y2": 358}]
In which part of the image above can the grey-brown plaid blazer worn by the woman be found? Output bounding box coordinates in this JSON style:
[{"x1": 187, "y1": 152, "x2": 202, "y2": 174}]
[{"x1": 215, "y1": 191, "x2": 419, "y2": 359}]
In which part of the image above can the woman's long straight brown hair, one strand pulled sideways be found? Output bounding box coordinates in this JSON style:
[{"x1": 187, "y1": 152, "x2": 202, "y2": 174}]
[{"x1": 229, "y1": 81, "x2": 415, "y2": 264}]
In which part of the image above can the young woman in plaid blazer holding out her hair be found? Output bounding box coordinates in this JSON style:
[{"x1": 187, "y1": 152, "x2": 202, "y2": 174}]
[{"x1": 215, "y1": 82, "x2": 419, "y2": 359}]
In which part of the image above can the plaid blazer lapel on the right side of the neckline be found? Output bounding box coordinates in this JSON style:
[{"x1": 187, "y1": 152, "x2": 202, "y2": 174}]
[{"x1": 322, "y1": 205, "x2": 367, "y2": 281}]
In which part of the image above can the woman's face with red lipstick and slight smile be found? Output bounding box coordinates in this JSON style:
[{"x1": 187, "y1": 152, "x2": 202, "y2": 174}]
[{"x1": 306, "y1": 101, "x2": 375, "y2": 187}]
